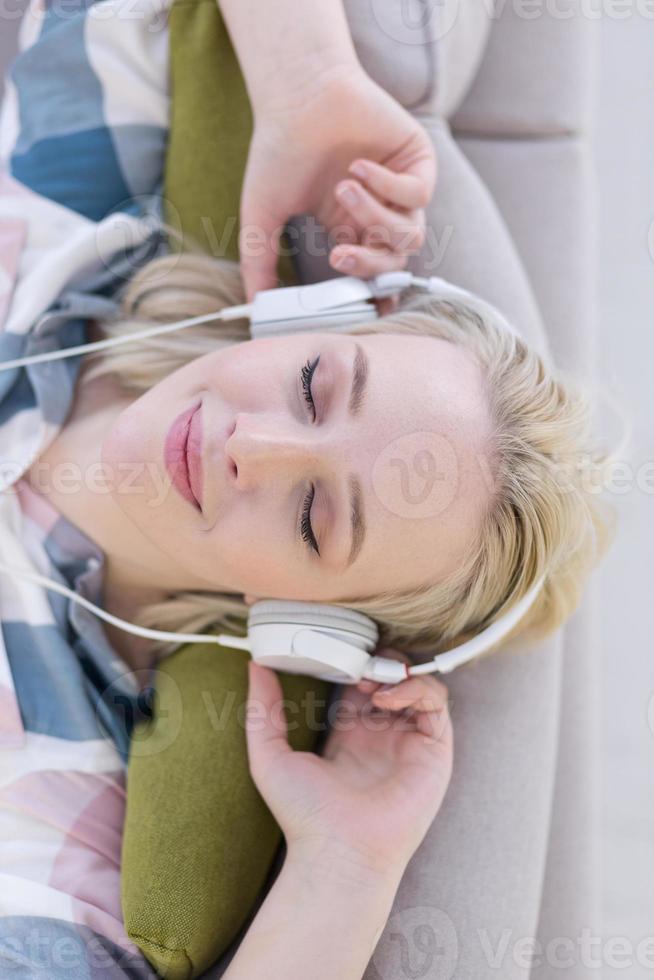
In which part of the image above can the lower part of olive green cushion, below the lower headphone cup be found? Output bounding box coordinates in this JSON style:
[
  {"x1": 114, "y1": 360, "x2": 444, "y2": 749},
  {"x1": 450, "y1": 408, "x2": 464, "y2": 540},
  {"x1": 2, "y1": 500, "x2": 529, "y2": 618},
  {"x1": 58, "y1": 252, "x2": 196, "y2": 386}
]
[{"x1": 122, "y1": 644, "x2": 331, "y2": 980}]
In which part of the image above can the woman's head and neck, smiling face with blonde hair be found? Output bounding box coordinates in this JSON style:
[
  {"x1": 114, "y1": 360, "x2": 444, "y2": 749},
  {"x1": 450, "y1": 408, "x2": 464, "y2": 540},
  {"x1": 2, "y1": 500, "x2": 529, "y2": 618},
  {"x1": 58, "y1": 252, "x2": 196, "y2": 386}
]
[{"x1": 55, "y1": 255, "x2": 604, "y2": 668}]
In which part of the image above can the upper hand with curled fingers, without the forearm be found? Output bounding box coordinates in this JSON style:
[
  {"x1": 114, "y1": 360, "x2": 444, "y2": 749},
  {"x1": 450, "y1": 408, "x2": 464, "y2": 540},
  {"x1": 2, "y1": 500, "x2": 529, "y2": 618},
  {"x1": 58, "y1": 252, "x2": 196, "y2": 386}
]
[{"x1": 241, "y1": 64, "x2": 436, "y2": 299}]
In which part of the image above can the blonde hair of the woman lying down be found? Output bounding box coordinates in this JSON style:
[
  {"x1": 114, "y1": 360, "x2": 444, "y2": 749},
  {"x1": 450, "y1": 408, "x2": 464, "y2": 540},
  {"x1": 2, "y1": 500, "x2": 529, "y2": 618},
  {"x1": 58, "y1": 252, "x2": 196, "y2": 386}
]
[{"x1": 87, "y1": 254, "x2": 613, "y2": 654}]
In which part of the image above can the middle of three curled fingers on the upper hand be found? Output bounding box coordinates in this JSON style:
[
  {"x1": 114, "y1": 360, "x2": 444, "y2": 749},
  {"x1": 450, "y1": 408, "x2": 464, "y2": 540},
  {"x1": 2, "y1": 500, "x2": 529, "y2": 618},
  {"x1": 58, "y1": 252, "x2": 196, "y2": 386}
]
[{"x1": 335, "y1": 180, "x2": 425, "y2": 255}]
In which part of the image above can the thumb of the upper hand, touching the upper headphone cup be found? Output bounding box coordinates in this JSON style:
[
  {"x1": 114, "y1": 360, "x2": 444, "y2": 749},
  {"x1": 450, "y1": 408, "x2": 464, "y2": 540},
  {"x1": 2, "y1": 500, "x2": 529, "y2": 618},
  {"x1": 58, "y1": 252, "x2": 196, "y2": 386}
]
[{"x1": 239, "y1": 183, "x2": 288, "y2": 303}]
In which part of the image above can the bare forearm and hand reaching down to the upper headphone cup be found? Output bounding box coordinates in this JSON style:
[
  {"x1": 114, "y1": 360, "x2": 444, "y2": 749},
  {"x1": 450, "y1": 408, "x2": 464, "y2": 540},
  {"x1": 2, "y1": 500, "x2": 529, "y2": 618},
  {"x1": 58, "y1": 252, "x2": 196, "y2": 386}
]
[{"x1": 218, "y1": 0, "x2": 436, "y2": 299}]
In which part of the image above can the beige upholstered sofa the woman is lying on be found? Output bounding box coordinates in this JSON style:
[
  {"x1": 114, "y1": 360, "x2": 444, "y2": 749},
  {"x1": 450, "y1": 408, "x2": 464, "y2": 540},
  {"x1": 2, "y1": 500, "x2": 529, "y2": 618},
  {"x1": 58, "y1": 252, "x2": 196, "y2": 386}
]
[{"x1": 0, "y1": 0, "x2": 601, "y2": 980}]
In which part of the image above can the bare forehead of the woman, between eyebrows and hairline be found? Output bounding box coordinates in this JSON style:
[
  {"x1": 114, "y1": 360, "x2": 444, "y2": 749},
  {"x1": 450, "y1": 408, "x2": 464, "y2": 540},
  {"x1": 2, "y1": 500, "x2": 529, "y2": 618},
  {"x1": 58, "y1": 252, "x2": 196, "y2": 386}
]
[{"x1": 330, "y1": 334, "x2": 490, "y2": 594}]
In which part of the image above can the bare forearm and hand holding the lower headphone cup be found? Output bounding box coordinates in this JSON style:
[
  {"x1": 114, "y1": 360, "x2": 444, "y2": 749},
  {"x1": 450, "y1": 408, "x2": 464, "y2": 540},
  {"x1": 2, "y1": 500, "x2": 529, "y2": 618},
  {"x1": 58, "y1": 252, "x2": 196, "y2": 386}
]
[{"x1": 224, "y1": 664, "x2": 452, "y2": 980}]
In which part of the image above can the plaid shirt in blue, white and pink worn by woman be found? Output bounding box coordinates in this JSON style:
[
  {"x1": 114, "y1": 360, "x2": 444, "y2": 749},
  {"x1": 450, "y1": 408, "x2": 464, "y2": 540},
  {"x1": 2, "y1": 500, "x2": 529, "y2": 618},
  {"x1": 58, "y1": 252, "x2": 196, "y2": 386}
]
[{"x1": 0, "y1": 0, "x2": 173, "y2": 980}]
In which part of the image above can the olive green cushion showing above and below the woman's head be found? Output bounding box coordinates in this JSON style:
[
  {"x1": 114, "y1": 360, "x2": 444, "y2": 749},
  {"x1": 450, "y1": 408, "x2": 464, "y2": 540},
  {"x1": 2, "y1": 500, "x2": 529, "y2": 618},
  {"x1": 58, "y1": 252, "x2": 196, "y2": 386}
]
[{"x1": 121, "y1": 0, "x2": 331, "y2": 980}]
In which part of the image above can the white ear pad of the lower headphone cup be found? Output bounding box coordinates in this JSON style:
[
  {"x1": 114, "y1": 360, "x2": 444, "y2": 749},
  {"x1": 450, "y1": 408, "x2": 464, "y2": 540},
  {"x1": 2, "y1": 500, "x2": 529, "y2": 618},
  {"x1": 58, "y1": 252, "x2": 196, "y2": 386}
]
[{"x1": 248, "y1": 599, "x2": 379, "y2": 651}]
